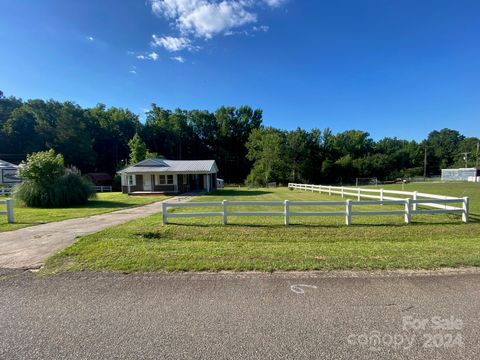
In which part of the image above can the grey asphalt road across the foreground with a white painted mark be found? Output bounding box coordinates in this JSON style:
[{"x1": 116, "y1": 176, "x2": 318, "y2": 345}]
[{"x1": 0, "y1": 269, "x2": 480, "y2": 359}]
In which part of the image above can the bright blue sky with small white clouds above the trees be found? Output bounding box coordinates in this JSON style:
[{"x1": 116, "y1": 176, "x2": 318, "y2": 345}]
[{"x1": 0, "y1": 0, "x2": 480, "y2": 140}]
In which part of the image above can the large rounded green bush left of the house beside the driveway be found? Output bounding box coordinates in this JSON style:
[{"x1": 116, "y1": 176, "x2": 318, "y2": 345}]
[{"x1": 14, "y1": 150, "x2": 95, "y2": 207}]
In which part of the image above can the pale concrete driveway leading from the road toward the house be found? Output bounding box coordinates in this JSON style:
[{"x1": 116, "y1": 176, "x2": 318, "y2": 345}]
[{"x1": 0, "y1": 196, "x2": 192, "y2": 269}]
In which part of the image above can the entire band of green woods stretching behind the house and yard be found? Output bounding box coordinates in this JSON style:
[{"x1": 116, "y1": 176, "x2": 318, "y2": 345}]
[{"x1": 0, "y1": 92, "x2": 479, "y2": 185}]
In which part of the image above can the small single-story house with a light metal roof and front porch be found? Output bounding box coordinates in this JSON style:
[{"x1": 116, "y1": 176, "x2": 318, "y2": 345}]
[{"x1": 118, "y1": 159, "x2": 218, "y2": 194}]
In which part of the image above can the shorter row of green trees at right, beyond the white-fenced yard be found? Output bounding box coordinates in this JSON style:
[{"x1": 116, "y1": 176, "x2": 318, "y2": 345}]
[{"x1": 247, "y1": 127, "x2": 479, "y2": 184}]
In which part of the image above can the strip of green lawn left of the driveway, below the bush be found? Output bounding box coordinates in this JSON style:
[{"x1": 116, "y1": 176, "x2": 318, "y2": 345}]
[{"x1": 0, "y1": 192, "x2": 166, "y2": 232}]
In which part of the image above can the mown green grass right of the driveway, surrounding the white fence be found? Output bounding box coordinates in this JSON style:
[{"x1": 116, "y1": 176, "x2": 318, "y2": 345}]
[{"x1": 43, "y1": 183, "x2": 480, "y2": 274}]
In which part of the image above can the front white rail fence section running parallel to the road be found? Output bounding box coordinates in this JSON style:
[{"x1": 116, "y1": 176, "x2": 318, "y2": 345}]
[{"x1": 162, "y1": 194, "x2": 469, "y2": 225}]
